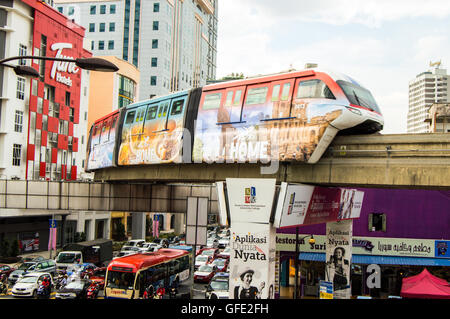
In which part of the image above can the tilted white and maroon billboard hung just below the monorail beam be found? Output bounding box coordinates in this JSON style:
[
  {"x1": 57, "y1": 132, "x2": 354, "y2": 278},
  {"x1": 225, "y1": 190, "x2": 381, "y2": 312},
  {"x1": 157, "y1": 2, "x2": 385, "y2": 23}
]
[{"x1": 274, "y1": 183, "x2": 364, "y2": 228}]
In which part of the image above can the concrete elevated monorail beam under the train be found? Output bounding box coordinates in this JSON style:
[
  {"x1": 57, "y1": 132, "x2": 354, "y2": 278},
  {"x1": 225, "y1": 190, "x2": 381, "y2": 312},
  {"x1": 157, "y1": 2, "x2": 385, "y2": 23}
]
[{"x1": 95, "y1": 133, "x2": 450, "y2": 189}]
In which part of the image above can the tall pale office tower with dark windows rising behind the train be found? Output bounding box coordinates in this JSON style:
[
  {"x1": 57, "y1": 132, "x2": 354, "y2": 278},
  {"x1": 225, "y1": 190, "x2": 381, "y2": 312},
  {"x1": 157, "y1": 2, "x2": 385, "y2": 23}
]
[{"x1": 54, "y1": 0, "x2": 218, "y2": 100}]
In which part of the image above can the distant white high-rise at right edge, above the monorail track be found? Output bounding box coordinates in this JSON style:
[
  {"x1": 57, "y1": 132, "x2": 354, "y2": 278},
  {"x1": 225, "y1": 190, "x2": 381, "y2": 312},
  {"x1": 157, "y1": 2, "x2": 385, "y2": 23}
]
[{"x1": 407, "y1": 62, "x2": 450, "y2": 133}]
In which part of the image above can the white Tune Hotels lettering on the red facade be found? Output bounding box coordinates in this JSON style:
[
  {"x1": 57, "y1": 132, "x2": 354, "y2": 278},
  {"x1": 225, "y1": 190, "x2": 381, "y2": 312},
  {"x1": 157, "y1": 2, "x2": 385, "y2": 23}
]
[{"x1": 50, "y1": 42, "x2": 79, "y2": 87}]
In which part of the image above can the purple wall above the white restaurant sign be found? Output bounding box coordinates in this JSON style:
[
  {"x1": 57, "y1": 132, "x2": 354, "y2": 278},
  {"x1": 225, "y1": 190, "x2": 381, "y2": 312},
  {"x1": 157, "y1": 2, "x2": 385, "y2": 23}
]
[{"x1": 277, "y1": 188, "x2": 450, "y2": 239}]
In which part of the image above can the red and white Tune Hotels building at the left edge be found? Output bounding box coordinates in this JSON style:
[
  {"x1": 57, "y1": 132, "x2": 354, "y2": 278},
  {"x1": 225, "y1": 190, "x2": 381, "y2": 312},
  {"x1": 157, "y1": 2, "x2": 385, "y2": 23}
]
[{"x1": 0, "y1": 0, "x2": 92, "y2": 180}]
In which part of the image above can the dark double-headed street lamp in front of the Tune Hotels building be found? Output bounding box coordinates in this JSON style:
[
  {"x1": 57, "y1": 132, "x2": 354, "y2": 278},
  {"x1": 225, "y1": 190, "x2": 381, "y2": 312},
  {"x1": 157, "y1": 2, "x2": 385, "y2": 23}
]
[{"x1": 0, "y1": 55, "x2": 119, "y2": 77}]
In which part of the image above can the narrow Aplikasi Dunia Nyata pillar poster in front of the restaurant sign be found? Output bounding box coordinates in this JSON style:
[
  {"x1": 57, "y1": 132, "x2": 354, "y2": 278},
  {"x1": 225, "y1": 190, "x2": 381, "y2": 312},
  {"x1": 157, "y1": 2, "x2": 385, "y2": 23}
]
[{"x1": 325, "y1": 220, "x2": 353, "y2": 299}]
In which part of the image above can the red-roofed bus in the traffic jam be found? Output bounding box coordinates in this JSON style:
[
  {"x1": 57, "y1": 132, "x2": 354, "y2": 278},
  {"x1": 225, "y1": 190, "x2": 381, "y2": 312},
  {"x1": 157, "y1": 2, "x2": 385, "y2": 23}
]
[{"x1": 105, "y1": 248, "x2": 190, "y2": 299}]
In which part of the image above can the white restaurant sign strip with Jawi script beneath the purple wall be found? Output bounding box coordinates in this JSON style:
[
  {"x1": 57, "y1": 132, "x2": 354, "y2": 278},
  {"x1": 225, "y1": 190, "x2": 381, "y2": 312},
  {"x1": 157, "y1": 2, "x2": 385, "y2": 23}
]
[{"x1": 277, "y1": 234, "x2": 444, "y2": 258}]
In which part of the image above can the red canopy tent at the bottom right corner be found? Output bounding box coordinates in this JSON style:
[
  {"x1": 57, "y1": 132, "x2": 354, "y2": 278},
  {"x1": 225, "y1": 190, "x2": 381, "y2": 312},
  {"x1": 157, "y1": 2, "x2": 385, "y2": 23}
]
[{"x1": 400, "y1": 269, "x2": 450, "y2": 299}]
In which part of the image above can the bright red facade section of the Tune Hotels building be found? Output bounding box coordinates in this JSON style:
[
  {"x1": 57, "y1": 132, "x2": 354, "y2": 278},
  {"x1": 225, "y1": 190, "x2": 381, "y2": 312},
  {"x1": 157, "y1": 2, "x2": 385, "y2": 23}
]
[{"x1": 23, "y1": 0, "x2": 92, "y2": 180}]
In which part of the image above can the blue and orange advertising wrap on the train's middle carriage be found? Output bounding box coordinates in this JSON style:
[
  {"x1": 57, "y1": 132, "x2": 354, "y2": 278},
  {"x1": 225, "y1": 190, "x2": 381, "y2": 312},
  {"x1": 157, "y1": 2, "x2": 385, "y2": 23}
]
[{"x1": 118, "y1": 97, "x2": 186, "y2": 165}]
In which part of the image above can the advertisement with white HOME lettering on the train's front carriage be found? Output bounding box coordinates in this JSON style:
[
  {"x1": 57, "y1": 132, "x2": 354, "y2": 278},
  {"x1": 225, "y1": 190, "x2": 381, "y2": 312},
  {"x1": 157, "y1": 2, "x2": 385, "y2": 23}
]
[{"x1": 193, "y1": 88, "x2": 342, "y2": 163}]
